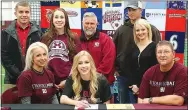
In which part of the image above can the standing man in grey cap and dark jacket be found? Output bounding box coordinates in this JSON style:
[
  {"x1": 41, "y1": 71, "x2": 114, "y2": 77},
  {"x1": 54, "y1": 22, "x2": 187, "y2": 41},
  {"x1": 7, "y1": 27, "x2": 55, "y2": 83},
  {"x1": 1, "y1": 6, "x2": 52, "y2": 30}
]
[{"x1": 113, "y1": 1, "x2": 161, "y2": 103}]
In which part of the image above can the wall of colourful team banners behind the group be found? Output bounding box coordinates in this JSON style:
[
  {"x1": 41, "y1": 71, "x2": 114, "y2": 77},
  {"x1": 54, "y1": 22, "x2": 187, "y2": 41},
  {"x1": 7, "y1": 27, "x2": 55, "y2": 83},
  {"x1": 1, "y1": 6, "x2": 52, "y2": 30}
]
[{"x1": 2, "y1": 0, "x2": 188, "y2": 63}]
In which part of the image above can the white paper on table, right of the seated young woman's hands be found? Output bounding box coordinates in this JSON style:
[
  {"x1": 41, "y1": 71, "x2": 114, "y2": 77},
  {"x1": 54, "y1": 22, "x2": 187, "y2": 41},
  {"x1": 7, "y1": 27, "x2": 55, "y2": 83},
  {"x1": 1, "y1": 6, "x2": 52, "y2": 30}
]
[{"x1": 106, "y1": 104, "x2": 135, "y2": 110}]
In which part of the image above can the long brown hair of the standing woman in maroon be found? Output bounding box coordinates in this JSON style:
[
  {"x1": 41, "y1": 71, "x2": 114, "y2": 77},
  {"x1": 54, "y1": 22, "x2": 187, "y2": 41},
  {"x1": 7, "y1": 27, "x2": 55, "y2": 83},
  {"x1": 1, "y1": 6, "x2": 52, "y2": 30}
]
[{"x1": 41, "y1": 8, "x2": 76, "y2": 56}]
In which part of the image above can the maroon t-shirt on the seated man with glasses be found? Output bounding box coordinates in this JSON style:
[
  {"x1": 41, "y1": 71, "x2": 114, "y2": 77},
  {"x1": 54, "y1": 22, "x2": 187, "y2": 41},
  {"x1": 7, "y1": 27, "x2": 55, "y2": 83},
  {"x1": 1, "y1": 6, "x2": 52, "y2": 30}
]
[{"x1": 138, "y1": 63, "x2": 188, "y2": 98}]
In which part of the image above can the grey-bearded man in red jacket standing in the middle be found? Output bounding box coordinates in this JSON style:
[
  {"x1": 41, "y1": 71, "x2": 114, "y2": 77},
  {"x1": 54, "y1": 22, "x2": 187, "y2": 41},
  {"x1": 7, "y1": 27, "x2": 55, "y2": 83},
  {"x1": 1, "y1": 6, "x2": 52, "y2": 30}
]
[{"x1": 80, "y1": 12, "x2": 116, "y2": 84}]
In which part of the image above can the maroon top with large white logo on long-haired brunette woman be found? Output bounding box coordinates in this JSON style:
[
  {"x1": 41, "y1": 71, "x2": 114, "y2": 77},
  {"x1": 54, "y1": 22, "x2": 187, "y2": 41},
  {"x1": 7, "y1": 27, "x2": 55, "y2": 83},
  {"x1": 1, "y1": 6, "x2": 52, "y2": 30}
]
[{"x1": 48, "y1": 34, "x2": 81, "y2": 85}]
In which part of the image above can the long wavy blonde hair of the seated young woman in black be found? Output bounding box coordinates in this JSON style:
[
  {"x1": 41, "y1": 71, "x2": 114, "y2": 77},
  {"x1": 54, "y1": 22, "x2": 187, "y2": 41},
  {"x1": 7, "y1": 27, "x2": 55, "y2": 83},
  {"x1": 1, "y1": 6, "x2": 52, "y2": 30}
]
[{"x1": 71, "y1": 51, "x2": 98, "y2": 103}]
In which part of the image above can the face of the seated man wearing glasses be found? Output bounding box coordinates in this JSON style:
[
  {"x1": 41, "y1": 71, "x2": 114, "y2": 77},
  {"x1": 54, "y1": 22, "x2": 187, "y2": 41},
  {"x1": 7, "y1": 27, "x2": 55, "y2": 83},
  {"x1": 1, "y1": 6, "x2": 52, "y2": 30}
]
[{"x1": 156, "y1": 45, "x2": 175, "y2": 66}]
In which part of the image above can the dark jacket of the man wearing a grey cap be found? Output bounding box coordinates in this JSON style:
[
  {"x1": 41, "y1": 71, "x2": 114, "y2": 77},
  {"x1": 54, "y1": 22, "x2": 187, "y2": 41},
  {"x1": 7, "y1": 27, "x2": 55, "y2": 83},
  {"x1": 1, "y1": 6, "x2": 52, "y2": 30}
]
[{"x1": 113, "y1": 19, "x2": 161, "y2": 84}]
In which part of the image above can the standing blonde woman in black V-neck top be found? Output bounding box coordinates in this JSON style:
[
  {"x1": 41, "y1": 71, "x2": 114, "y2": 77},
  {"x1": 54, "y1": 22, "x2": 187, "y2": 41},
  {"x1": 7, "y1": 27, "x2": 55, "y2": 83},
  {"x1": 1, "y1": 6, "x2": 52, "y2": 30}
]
[{"x1": 130, "y1": 19, "x2": 157, "y2": 102}]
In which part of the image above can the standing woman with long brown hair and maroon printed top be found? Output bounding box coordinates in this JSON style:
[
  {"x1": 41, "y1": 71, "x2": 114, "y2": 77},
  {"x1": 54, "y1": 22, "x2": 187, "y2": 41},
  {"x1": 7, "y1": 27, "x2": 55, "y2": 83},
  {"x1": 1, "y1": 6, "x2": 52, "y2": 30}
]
[{"x1": 41, "y1": 8, "x2": 81, "y2": 90}]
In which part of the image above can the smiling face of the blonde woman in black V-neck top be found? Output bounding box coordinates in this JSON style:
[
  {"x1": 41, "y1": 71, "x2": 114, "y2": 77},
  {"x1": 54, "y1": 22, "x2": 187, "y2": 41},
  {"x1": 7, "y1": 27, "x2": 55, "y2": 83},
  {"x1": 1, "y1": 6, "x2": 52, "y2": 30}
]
[{"x1": 135, "y1": 24, "x2": 148, "y2": 41}]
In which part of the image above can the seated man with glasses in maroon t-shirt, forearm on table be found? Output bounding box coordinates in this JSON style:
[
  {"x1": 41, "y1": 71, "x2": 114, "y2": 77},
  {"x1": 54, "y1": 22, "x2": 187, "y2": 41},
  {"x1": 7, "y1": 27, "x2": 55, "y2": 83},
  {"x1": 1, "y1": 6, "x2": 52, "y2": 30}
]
[{"x1": 138, "y1": 41, "x2": 188, "y2": 106}]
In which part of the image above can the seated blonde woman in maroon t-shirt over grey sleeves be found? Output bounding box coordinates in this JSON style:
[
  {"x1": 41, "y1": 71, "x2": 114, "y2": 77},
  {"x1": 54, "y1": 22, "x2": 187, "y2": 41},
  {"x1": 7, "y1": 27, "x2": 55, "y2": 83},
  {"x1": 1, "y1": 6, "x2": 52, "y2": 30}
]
[{"x1": 17, "y1": 42, "x2": 58, "y2": 104}]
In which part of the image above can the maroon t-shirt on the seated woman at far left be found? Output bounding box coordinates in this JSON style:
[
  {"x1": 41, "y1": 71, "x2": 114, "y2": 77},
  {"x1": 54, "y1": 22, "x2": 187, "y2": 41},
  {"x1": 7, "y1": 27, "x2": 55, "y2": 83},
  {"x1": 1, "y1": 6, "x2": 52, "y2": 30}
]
[{"x1": 17, "y1": 69, "x2": 56, "y2": 104}]
